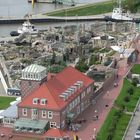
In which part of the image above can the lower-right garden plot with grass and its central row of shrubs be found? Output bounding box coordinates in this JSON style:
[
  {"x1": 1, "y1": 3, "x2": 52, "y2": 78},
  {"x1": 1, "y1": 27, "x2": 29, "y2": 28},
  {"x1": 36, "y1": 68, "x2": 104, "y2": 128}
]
[{"x1": 97, "y1": 108, "x2": 131, "y2": 140}]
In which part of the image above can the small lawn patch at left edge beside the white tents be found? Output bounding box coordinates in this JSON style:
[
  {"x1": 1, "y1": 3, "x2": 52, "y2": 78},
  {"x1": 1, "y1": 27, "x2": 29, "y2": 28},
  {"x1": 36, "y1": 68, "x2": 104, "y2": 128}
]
[{"x1": 0, "y1": 96, "x2": 16, "y2": 110}]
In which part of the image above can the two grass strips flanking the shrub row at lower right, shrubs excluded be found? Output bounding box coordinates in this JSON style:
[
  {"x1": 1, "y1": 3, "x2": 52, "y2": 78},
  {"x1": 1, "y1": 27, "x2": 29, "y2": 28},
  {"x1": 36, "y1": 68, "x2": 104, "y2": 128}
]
[{"x1": 97, "y1": 108, "x2": 131, "y2": 140}]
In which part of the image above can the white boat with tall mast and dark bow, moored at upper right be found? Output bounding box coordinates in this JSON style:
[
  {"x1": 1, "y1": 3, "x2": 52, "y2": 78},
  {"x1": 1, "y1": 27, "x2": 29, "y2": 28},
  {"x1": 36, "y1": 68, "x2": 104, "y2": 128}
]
[{"x1": 105, "y1": 0, "x2": 134, "y2": 21}]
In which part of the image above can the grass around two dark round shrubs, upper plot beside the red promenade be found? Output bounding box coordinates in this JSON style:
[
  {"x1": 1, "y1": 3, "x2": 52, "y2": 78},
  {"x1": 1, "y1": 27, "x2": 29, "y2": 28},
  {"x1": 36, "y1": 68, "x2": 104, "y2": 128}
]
[{"x1": 115, "y1": 79, "x2": 140, "y2": 111}]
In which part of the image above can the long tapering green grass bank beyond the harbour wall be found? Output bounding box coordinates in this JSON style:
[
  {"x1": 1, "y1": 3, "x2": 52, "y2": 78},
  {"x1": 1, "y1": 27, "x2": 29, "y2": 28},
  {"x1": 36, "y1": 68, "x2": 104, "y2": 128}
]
[{"x1": 47, "y1": 1, "x2": 114, "y2": 16}]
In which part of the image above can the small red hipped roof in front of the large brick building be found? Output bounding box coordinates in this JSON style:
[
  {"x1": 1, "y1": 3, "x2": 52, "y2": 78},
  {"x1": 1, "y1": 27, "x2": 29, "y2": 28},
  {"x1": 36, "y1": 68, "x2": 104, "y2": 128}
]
[{"x1": 44, "y1": 128, "x2": 68, "y2": 138}]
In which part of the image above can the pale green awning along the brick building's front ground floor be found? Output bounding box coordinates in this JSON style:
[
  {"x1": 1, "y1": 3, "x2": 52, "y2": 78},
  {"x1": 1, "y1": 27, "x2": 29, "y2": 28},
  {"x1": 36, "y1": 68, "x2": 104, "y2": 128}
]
[{"x1": 14, "y1": 118, "x2": 48, "y2": 129}]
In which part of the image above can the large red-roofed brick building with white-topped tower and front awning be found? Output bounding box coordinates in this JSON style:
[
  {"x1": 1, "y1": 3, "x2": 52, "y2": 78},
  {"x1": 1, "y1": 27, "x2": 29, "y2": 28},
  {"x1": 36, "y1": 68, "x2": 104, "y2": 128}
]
[{"x1": 15, "y1": 65, "x2": 94, "y2": 139}]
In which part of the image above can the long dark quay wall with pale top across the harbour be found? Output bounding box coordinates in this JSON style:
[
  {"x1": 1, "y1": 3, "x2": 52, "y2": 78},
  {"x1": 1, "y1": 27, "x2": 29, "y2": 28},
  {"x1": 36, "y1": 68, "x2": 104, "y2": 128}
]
[{"x1": 0, "y1": 15, "x2": 140, "y2": 24}]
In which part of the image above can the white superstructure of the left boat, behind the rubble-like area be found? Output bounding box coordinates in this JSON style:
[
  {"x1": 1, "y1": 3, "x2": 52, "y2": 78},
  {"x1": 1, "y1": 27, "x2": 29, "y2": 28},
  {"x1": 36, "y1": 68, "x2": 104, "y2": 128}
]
[{"x1": 17, "y1": 21, "x2": 38, "y2": 34}]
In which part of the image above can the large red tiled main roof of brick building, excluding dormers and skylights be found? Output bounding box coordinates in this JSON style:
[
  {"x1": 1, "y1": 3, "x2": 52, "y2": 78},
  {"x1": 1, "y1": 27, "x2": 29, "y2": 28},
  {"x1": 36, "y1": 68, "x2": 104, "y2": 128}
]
[{"x1": 18, "y1": 66, "x2": 93, "y2": 110}]
